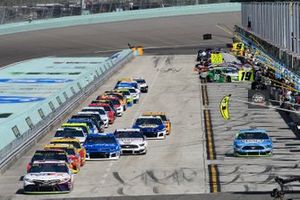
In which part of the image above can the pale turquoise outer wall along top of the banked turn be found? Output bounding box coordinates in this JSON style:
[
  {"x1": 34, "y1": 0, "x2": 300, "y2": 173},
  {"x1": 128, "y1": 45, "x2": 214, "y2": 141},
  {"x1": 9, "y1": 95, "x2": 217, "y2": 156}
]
[{"x1": 0, "y1": 3, "x2": 241, "y2": 35}]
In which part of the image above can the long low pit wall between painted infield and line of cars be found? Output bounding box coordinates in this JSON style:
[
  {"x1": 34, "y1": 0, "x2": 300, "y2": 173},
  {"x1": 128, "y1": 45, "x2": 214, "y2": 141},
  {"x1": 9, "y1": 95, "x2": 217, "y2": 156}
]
[{"x1": 0, "y1": 50, "x2": 134, "y2": 173}]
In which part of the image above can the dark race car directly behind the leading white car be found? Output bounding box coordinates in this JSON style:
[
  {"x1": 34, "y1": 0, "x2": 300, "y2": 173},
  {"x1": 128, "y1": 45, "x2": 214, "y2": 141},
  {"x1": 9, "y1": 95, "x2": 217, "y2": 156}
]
[{"x1": 26, "y1": 149, "x2": 71, "y2": 173}]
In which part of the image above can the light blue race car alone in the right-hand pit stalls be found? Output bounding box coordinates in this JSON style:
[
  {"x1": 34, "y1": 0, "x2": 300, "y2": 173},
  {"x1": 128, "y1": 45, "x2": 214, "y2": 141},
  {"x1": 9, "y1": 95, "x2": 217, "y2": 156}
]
[{"x1": 233, "y1": 129, "x2": 273, "y2": 156}]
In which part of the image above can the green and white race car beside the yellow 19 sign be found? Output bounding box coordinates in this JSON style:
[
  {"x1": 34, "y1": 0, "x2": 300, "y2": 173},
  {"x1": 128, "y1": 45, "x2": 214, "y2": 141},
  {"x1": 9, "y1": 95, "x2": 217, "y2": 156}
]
[{"x1": 199, "y1": 67, "x2": 239, "y2": 83}]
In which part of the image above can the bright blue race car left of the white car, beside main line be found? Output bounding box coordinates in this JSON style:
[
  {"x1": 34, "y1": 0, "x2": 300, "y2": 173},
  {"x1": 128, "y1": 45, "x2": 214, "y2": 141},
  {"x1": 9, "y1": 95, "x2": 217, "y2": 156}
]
[{"x1": 83, "y1": 133, "x2": 121, "y2": 160}]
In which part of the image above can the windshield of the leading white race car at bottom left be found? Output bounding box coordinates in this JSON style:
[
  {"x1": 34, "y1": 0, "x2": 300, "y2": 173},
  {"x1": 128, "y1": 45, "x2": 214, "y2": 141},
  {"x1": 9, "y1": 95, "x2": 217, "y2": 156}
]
[{"x1": 29, "y1": 163, "x2": 69, "y2": 173}]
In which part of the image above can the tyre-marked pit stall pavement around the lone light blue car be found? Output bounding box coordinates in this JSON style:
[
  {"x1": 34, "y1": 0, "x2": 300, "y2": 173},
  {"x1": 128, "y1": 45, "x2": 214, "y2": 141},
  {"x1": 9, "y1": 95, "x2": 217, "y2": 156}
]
[{"x1": 202, "y1": 83, "x2": 300, "y2": 192}]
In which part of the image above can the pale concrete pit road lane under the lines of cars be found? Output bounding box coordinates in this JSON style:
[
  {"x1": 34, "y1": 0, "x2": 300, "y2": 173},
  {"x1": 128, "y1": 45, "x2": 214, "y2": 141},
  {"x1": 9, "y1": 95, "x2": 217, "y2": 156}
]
[{"x1": 0, "y1": 55, "x2": 209, "y2": 199}]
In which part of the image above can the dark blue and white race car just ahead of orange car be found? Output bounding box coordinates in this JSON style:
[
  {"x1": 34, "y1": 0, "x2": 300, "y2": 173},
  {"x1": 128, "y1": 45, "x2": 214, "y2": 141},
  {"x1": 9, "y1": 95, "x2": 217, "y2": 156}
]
[{"x1": 132, "y1": 116, "x2": 167, "y2": 139}]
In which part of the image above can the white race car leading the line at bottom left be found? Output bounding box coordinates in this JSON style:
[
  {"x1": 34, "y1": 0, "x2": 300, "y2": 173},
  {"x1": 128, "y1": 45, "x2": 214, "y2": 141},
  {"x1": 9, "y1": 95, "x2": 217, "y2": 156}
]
[{"x1": 23, "y1": 160, "x2": 74, "y2": 194}]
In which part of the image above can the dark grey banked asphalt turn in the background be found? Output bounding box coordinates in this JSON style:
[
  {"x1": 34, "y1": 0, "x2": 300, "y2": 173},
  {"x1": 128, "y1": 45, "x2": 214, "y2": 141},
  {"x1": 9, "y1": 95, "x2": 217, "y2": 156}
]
[{"x1": 0, "y1": 12, "x2": 240, "y2": 66}]
